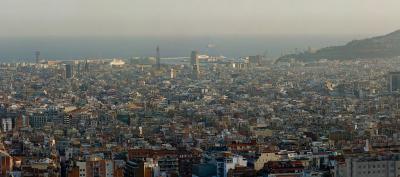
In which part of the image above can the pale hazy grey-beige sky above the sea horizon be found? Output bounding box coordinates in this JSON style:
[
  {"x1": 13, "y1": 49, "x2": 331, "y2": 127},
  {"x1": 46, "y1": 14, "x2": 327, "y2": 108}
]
[{"x1": 0, "y1": 0, "x2": 400, "y2": 37}]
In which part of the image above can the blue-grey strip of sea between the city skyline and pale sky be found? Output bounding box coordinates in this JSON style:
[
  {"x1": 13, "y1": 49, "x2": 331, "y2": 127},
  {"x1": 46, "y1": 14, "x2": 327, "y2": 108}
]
[{"x1": 0, "y1": 35, "x2": 368, "y2": 62}]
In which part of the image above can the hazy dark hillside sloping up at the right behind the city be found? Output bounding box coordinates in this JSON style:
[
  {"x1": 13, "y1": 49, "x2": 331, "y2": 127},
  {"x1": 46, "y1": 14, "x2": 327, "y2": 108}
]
[{"x1": 278, "y1": 30, "x2": 400, "y2": 61}]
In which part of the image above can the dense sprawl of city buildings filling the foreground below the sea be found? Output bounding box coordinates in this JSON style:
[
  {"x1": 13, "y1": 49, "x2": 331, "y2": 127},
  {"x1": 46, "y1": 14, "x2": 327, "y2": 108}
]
[{"x1": 0, "y1": 47, "x2": 400, "y2": 177}]
